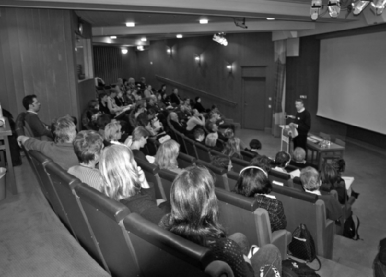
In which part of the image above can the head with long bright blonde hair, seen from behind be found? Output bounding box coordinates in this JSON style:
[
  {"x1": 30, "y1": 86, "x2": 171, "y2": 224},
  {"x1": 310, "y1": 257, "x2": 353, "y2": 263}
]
[{"x1": 99, "y1": 145, "x2": 141, "y2": 201}]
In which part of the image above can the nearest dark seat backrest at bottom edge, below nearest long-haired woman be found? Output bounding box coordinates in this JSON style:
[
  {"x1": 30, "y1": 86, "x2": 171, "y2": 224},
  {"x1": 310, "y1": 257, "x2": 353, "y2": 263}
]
[{"x1": 124, "y1": 213, "x2": 231, "y2": 277}]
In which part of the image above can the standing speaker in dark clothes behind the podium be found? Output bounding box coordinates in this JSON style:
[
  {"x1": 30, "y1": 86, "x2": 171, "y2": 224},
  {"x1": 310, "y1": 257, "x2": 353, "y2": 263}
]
[{"x1": 287, "y1": 99, "x2": 311, "y2": 152}]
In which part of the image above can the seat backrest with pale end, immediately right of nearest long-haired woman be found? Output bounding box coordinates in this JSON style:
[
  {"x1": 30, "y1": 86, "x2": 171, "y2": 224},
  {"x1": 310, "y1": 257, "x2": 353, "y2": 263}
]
[{"x1": 216, "y1": 188, "x2": 291, "y2": 259}]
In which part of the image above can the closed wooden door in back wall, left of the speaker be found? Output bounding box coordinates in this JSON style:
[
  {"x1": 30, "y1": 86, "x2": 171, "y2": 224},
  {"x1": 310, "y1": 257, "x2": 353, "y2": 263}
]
[{"x1": 242, "y1": 78, "x2": 265, "y2": 130}]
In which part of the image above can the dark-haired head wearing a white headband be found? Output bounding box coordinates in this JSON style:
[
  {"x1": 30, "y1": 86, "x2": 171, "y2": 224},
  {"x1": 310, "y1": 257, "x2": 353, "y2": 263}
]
[{"x1": 235, "y1": 166, "x2": 272, "y2": 197}]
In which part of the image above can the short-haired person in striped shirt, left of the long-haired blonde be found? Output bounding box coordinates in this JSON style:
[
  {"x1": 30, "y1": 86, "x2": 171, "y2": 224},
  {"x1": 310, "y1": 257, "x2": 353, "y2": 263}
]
[{"x1": 68, "y1": 130, "x2": 103, "y2": 191}]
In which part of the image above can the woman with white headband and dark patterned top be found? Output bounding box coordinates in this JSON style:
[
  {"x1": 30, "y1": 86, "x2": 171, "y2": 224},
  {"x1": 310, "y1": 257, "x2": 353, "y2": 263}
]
[{"x1": 234, "y1": 166, "x2": 287, "y2": 232}]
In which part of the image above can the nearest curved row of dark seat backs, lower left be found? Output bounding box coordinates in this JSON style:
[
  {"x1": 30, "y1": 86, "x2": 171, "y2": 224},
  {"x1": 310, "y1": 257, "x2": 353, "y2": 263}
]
[{"x1": 26, "y1": 146, "x2": 238, "y2": 277}]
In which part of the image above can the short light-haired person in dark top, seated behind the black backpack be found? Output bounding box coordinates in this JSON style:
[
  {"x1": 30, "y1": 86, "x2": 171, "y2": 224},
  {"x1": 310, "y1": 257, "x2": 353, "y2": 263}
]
[{"x1": 300, "y1": 166, "x2": 343, "y2": 221}]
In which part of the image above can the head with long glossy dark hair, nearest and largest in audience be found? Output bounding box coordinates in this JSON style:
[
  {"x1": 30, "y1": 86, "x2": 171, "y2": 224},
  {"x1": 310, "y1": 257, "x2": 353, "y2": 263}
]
[{"x1": 166, "y1": 166, "x2": 225, "y2": 240}]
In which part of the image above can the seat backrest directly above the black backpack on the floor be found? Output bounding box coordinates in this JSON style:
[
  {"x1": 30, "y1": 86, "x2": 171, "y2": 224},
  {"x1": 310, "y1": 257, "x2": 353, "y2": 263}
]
[{"x1": 272, "y1": 185, "x2": 335, "y2": 259}]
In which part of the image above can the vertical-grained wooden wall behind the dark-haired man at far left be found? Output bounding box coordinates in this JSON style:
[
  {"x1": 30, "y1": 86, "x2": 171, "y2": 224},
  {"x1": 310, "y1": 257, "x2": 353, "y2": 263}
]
[{"x1": 0, "y1": 8, "x2": 79, "y2": 123}]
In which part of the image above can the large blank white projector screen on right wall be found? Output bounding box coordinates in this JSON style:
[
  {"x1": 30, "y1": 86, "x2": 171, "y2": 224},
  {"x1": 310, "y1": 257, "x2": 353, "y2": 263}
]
[{"x1": 317, "y1": 32, "x2": 386, "y2": 134}]
